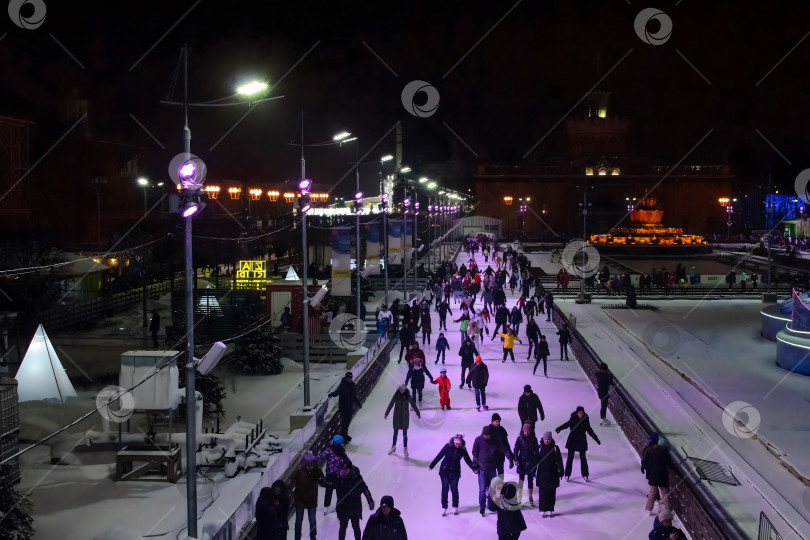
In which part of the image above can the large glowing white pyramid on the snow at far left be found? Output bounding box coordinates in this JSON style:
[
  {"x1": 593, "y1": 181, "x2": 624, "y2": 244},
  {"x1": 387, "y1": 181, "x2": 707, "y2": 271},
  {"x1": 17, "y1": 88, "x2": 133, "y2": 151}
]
[{"x1": 16, "y1": 324, "x2": 76, "y2": 403}]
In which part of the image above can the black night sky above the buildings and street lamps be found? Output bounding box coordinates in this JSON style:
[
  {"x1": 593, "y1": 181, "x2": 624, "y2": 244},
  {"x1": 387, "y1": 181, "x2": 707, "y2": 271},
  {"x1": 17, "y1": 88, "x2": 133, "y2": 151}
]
[{"x1": 0, "y1": 0, "x2": 810, "y2": 196}]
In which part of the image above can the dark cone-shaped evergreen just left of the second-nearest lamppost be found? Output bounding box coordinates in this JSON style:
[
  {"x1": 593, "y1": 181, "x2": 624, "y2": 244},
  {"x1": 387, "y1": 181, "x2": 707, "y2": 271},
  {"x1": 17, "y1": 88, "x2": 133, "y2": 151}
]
[{"x1": 230, "y1": 293, "x2": 284, "y2": 375}]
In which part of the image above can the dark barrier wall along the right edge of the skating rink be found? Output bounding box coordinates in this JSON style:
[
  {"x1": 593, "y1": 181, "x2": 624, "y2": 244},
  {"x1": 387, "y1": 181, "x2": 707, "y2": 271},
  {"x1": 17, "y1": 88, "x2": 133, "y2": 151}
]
[{"x1": 552, "y1": 306, "x2": 746, "y2": 540}]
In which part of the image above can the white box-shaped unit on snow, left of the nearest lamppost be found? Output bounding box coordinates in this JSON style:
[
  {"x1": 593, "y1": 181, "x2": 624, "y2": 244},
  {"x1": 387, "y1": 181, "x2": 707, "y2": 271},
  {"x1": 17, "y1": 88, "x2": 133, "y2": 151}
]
[{"x1": 118, "y1": 351, "x2": 180, "y2": 410}]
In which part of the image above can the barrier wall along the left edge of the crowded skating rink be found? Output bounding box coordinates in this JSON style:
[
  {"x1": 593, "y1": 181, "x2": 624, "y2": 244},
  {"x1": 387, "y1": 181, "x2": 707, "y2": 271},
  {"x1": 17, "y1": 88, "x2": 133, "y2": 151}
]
[{"x1": 201, "y1": 336, "x2": 397, "y2": 540}]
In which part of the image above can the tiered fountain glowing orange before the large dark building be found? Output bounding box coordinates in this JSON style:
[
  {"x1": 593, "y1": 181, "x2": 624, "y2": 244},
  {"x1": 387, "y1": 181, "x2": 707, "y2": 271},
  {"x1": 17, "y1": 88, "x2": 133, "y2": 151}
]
[{"x1": 590, "y1": 190, "x2": 706, "y2": 246}]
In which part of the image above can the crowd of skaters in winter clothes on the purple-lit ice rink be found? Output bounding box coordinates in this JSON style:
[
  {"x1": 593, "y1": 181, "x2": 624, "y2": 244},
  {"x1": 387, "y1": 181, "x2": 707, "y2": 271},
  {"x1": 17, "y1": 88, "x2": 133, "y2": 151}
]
[{"x1": 256, "y1": 237, "x2": 685, "y2": 540}]
